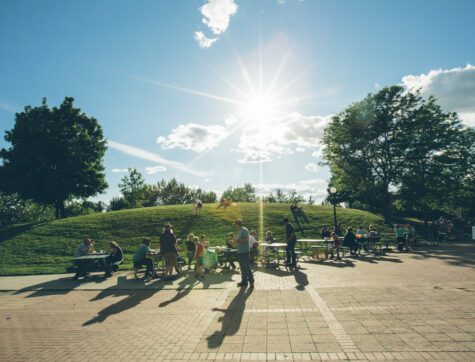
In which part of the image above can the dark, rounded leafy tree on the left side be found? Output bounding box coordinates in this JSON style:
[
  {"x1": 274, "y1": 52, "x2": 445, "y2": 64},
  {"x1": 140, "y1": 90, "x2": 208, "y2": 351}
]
[{"x1": 0, "y1": 97, "x2": 107, "y2": 218}]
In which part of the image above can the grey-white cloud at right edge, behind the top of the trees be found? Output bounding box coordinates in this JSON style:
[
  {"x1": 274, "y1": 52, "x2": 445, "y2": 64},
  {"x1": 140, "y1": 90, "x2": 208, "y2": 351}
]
[{"x1": 402, "y1": 64, "x2": 475, "y2": 126}]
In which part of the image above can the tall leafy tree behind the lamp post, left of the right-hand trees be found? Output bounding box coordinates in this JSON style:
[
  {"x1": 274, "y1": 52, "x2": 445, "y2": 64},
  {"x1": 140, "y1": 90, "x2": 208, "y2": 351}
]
[{"x1": 323, "y1": 86, "x2": 422, "y2": 220}]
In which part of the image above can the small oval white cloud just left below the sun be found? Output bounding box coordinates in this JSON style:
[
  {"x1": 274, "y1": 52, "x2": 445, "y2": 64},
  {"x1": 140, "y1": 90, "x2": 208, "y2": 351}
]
[{"x1": 157, "y1": 123, "x2": 229, "y2": 153}]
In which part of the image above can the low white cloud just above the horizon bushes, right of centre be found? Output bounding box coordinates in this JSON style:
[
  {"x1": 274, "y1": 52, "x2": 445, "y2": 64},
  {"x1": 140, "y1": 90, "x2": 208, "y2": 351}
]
[{"x1": 253, "y1": 179, "x2": 328, "y2": 202}]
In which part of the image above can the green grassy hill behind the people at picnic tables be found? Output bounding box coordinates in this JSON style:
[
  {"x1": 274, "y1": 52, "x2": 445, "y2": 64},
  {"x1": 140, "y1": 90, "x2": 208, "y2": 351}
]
[{"x1": 0, "y1": 203, "x2": 398, "y2": 275}]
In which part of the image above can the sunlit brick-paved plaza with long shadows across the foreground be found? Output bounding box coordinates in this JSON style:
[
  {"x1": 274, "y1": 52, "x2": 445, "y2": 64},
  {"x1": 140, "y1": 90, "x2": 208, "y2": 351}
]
[{"x1": 0, "y1": 244, "x2": 475, "y2": 361}]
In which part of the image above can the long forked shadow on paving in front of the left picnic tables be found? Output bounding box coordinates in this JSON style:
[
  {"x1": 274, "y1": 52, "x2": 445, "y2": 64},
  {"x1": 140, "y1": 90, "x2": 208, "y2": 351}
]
[{"x1": 82, "y1": 277, "x2": 163, "y2": 327}]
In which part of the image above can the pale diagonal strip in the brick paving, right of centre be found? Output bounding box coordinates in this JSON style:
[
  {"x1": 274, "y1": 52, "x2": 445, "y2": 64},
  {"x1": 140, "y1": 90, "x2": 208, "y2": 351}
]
[{"x1": 307, "y1": 288, "x2": 360, "y2": 352}]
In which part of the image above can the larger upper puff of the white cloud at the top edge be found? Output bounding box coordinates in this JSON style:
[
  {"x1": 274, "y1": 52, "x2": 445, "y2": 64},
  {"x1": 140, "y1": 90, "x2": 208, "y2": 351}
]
[{"x1": 201, "y1": 0, "x2": 238, "y2": 35}]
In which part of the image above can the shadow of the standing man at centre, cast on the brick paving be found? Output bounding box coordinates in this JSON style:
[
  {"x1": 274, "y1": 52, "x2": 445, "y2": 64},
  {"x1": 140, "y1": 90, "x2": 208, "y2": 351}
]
[{"x1": 206, "y1": 288, "x2": 253, "y2": 349}]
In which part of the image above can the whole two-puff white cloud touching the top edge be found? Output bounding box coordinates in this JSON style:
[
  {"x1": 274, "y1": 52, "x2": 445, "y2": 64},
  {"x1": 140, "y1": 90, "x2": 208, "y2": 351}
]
[{"x1": 194, "y1": 0, "x2": 238, "y2": 48}]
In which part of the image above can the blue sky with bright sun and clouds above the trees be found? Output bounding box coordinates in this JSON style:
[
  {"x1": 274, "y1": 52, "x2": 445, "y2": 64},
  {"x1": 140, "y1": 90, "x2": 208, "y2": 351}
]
[{"x1": 0, "y1": 0, "x2": 475, "y2": 200}]
